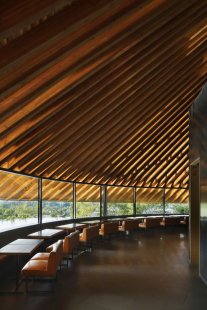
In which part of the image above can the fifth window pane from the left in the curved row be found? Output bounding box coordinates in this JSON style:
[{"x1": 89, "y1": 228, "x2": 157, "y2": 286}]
[{"x1": 136, "y1": 188, "x2": 163, "y2": 214}]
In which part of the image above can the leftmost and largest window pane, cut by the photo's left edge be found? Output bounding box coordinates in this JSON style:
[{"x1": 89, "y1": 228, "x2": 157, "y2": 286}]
[{"x1": 0, "y1": 171, "x2": 38, "y2": 231}]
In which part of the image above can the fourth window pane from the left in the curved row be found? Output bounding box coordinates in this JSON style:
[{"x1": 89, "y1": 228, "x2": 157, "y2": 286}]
[{"x1": 107, "y1": 186, "x2": 133, "y2": 215}]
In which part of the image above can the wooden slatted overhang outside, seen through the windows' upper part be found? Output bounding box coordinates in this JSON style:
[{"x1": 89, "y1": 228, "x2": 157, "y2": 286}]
[{"x1": 0, "y1": 171, "x2": 188, "y2": 205}]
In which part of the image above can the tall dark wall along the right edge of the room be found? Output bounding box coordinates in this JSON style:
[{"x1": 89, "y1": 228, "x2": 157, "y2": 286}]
[{"x1": 189, "y1": 84, "x2": 207, "y2": 282}]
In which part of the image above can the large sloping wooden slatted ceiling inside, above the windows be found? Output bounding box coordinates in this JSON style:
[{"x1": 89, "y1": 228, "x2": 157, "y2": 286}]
[{"x1": 0, "y1": 0, "x2": 207, "y2": 194}]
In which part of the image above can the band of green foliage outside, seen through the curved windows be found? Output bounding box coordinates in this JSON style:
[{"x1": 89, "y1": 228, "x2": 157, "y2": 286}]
[{"x1": 0, "y1": 200, "x2": 189, "y2": 221}]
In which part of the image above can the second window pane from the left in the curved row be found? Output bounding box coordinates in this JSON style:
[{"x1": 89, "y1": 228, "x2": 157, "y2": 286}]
[{"x1": 42, "y1": 179, "x2": 73, "y2": 223}]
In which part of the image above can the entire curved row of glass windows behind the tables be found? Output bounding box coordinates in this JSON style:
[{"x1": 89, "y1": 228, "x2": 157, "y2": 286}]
[{"x1": 0, "y1": 170, "x2": 189, "y2": 231}]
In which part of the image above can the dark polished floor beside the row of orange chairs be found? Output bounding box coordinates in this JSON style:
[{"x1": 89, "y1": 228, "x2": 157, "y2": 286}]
[{"x1": 0, "y1": 228, "x2": 207, "y2": 310}]
